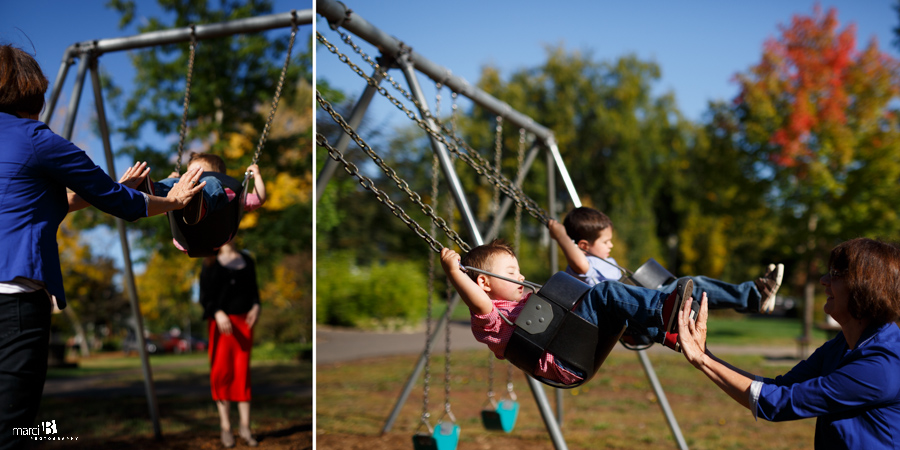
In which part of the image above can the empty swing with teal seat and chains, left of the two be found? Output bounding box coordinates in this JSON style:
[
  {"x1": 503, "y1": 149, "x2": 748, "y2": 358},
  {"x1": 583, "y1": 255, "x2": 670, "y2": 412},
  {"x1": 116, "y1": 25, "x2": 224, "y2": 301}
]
[{"x1": 413, "y1": 156, "x2": 460, "y2": 450}]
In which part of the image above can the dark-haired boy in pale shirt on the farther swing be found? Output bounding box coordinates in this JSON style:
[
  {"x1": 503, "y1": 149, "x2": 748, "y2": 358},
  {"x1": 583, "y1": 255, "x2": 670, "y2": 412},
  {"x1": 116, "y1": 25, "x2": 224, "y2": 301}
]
[{"x1": 547, "y1": 207, "x2": 784, "y2": 344}]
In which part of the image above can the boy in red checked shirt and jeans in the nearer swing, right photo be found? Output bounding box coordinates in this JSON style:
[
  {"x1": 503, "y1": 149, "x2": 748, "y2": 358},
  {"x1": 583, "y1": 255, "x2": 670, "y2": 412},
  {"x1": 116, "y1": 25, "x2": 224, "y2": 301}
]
[{"x1": 441, "y1": 240, "x2": 705, "y2": 385}]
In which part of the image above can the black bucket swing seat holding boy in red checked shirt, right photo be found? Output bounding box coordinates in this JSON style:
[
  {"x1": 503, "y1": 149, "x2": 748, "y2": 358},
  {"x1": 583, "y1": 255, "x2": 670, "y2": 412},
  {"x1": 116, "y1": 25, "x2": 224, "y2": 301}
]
[{"x1": 503, "y1": 272, "x2": 625, "y2": 389}]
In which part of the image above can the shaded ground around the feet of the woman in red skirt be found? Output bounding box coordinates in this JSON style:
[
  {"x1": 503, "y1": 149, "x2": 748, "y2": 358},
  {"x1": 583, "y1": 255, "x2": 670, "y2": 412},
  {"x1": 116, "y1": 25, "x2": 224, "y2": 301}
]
[{"x1": 38, "y1": 349, "x2": 313, "y2": 449}]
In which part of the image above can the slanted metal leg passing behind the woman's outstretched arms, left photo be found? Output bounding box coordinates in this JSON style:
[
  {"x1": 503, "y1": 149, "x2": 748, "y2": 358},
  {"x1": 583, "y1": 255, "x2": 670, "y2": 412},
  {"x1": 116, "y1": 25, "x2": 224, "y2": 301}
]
[{"x1": 89, "y1": 54, "x2": 162, "y2": 439}]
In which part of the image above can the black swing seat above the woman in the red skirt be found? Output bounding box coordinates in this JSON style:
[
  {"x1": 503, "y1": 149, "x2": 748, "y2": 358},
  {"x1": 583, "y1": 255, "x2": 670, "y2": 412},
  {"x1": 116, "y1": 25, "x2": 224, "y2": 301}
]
[{"x1": 167, "y1": 172, "x2": 244, "y2": 258}]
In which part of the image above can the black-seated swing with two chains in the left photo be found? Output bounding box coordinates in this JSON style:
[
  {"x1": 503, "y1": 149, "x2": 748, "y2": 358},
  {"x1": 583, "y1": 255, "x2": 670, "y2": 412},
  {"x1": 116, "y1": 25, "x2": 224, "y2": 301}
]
[{"x1": 162, "y1": 18, "x2": 298, "y2": 258}]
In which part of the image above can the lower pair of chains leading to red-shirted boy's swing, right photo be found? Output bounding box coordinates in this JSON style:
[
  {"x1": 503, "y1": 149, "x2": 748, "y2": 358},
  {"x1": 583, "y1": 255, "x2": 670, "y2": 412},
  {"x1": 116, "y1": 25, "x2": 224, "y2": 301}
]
[{"x1": 316, "y1": 90, "x2": 470, "y2": 253}]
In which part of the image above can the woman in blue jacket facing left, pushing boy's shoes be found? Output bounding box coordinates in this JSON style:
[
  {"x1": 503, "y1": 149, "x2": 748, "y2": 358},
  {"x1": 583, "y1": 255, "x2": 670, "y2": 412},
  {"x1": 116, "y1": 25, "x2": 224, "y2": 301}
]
[{"x1": 679, "y1": 238, "x2": 900, "y2": 450}]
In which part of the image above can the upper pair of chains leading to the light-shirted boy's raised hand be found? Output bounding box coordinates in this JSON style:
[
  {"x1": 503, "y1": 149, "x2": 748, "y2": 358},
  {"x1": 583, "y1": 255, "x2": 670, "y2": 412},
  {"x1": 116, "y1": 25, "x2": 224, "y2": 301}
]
[{"x1": 316, "y1": 31, "x2": 550, "y2": 224}]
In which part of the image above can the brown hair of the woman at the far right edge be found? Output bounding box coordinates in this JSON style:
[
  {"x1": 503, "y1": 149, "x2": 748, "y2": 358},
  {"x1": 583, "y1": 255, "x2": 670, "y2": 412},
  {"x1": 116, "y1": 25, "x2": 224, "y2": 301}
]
[{"x1": 828, "y1": 238, "x2": 900, "y2": 323}]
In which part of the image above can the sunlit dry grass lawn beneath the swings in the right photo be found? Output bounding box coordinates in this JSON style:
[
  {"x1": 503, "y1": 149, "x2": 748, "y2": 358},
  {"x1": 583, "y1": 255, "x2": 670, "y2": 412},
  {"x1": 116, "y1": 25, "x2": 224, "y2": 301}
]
[{"x1": 316, "y1": 314, "x2": 826, "y2": 450}]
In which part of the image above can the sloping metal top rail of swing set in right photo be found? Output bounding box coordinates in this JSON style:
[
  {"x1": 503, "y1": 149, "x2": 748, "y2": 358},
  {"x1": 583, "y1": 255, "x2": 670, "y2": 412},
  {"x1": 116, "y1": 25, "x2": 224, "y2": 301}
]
[{"x1": 316, "y1": 0, "x2": 555, "y2": 143}]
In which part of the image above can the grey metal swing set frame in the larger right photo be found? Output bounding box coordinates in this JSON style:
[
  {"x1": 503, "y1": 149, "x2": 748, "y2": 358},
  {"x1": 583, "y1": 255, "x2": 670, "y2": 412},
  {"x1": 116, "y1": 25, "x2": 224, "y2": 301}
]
[{"x1": 316, "y1": 0, "x2": 687, "y2": 450}]
